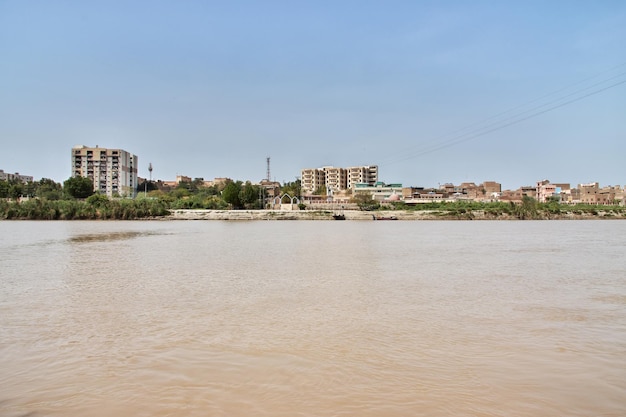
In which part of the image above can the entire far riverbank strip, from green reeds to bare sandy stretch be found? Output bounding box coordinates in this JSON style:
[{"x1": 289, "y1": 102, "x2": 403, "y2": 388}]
[{"x1": 0, "y1": 199, "x2": 626, "y2": 221}]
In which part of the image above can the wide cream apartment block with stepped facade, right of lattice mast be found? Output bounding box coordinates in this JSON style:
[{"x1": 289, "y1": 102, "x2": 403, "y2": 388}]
[{"x1": 300, "y1": 165, "x2": 378, "y2": 194}]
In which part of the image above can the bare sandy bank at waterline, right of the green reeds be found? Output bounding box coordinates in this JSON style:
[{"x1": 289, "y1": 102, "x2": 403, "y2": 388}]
[{"x1": 163, "y1": 209, "x2": 626, "y2": 221}]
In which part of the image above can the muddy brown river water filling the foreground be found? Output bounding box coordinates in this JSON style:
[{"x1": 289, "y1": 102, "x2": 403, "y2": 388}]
[{"x1": 0, "y1": 221, "x2": 626, "y2": 417}]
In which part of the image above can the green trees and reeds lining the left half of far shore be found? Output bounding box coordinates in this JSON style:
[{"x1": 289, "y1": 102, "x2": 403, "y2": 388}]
[{"x1": 0, "y1": 177, "x2": 299, "y2": 220}]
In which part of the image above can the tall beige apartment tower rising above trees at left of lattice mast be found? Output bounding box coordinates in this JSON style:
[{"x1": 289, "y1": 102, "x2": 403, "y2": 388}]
[{"x1": 72, "y1": 145, "x2": 138, "y2": 197}]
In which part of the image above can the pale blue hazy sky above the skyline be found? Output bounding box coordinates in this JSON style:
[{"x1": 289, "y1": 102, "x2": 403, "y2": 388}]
[{"x1": 0, "y1": 0, "x2": 626, "y2": 189}]
